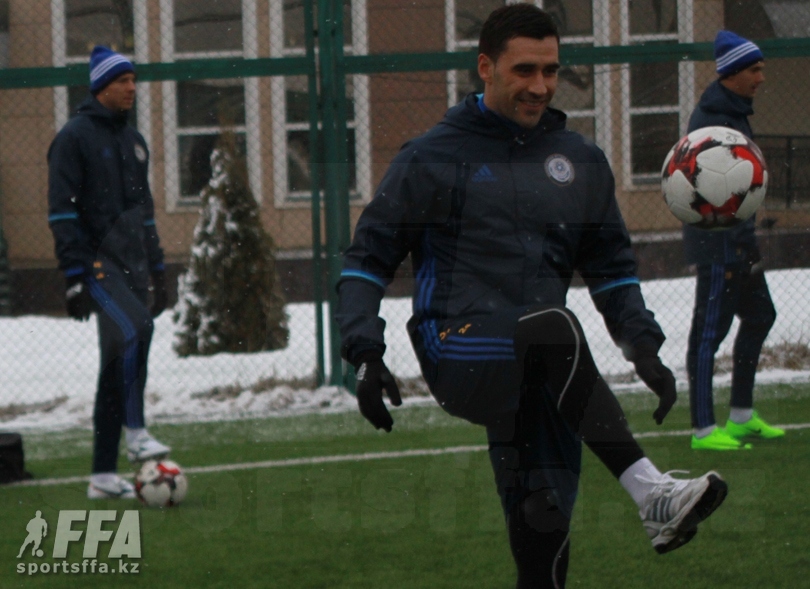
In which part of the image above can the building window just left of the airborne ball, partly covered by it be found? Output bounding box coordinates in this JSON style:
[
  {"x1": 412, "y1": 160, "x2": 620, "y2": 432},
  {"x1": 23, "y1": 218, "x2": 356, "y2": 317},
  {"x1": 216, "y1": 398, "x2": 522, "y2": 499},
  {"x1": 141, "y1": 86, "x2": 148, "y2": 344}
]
[{"x1": 621, "y1": 0, "x2": 694, "y2": 188}]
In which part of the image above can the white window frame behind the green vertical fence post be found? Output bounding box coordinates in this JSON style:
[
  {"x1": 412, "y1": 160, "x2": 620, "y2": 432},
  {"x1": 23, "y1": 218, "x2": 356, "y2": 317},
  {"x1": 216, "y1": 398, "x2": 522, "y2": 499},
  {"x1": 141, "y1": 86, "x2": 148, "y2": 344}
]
[{"x1": 269, "y1": 0, "x2": 372, "y2": 208}]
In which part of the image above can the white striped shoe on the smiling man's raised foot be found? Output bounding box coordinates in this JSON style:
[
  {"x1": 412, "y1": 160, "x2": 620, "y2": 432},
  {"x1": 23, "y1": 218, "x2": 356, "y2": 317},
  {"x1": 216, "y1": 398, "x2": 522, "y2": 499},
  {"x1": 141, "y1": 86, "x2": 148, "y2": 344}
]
[{"x1": 639, "y1": 471, "x2": 728, "y2": 554}]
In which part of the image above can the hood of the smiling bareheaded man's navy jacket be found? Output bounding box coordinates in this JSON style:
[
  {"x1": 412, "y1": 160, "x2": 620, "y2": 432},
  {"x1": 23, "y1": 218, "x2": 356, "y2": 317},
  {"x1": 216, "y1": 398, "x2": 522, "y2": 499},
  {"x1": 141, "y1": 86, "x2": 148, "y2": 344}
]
[{"x1": 440, "y1": 93, "x2": 568, "y2": 143}]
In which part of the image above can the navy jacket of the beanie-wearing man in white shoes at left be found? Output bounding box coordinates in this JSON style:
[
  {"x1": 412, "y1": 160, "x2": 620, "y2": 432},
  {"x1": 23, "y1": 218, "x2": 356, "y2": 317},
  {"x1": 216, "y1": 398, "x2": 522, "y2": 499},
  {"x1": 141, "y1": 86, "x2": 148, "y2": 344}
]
[{"x1": 48, "y1": 96, "x2": 163, "y2": 288}]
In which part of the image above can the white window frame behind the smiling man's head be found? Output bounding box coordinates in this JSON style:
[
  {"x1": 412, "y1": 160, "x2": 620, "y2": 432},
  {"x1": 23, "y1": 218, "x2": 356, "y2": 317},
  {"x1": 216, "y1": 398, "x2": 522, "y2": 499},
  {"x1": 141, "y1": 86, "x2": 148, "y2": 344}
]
[{"x1": 444, "y1": 0, "x2": 613, "y2": 161}]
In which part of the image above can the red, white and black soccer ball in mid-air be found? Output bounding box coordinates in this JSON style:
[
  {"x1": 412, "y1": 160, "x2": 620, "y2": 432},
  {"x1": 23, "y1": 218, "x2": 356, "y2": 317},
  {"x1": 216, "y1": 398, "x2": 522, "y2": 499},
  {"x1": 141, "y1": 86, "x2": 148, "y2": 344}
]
[{"x1": 661, "y1": 127, "x2": 768, "y2": 230}]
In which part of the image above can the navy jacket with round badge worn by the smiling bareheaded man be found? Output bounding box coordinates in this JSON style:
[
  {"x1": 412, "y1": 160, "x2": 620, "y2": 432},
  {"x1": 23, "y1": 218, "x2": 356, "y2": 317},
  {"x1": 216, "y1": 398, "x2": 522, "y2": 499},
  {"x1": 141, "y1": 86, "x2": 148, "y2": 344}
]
[{"x1": 336, "y1": 94, "x2": 664, "y2": 363}]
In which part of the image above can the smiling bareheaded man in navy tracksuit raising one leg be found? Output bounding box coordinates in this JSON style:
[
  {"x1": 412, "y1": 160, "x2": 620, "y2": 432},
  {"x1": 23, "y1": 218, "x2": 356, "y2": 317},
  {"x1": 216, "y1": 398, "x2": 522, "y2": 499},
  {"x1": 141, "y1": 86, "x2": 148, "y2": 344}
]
[{"x1": 336, "y1": 3, "x2": 726, "y2": 588}]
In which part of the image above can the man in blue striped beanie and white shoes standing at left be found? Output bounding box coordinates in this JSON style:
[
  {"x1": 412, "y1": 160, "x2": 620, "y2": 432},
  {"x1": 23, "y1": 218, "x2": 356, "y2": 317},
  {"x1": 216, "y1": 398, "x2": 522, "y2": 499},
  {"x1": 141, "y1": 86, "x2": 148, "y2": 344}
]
[{"x1": 48, "y1": 46, "x2": 170, "y2": 499}]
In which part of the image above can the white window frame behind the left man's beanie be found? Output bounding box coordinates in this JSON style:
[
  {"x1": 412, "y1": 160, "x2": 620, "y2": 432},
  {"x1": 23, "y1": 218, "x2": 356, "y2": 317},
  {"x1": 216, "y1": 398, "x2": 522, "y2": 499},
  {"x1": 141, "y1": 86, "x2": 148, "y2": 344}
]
[{"x1": 51, "y1": 0, "x2": 152, "y2": 161}]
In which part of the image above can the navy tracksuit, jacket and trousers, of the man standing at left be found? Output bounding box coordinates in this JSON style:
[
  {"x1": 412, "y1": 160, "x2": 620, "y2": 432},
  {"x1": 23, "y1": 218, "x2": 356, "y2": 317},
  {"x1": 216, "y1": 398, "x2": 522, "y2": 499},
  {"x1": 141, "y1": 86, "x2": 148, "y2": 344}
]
[{"x1": 48, "y1": 96, "x2": 163, "y2": 472}]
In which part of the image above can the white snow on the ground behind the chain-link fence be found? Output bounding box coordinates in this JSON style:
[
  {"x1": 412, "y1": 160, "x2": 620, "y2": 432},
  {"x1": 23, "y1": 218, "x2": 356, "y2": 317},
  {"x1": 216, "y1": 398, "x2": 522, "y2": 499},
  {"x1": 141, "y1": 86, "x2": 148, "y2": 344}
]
[{"x1": 0, "y1": 269, "x2": 810, "y2": 430}]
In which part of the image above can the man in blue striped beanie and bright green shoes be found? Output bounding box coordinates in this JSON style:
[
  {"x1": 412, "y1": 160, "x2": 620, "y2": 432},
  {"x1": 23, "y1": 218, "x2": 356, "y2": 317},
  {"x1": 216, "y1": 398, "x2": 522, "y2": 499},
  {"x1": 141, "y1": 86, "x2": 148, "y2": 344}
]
[{"x1": 683, "y1": 31, "x2": 785, "y2": 450}]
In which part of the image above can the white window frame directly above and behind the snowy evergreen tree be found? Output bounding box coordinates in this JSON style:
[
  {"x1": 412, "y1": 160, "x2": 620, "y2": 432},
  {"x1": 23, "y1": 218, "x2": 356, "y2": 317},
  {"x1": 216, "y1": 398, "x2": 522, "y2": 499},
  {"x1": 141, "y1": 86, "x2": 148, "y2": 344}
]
[{"x1": 158, "y1": 0, "x2": 262, "y2": 212}]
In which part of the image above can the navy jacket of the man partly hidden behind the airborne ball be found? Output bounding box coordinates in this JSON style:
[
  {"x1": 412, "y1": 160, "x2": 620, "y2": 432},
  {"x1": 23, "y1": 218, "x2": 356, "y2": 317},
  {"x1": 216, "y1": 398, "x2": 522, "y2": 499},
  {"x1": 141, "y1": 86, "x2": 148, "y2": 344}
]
[{"x1": 683, "y1": 80, "x2": 756, "y2": 265}]
